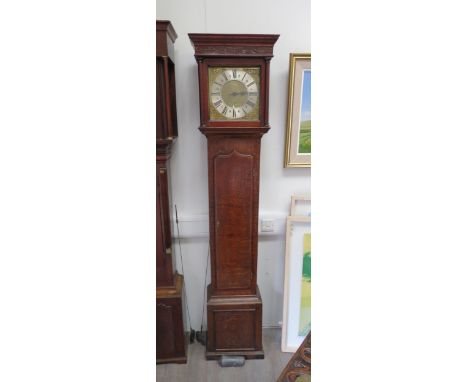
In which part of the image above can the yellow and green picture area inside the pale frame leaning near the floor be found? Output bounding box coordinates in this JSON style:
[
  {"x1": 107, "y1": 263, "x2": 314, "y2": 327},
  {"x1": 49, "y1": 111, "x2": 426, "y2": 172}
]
[{"x1": 299, "y1": 233, "x2": 312, "y2": 336}]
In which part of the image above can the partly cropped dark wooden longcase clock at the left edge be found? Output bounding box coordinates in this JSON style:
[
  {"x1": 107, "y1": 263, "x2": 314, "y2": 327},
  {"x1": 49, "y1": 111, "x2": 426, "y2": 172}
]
[{"x1": 156, "y1": 21, "x2": 187, "y2": 363}]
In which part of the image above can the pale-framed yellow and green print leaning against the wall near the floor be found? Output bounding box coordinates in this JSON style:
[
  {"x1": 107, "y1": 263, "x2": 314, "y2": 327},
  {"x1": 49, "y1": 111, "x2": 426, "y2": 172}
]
[{"x1": 281, "y1": 216, "x2": 311, "y2": 352}]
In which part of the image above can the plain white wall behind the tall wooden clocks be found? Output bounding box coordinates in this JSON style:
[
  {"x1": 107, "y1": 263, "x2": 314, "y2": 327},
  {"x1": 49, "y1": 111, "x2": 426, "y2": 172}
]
[{"x1": 156, "y1": 0, "x2": 310, "y2": 330}]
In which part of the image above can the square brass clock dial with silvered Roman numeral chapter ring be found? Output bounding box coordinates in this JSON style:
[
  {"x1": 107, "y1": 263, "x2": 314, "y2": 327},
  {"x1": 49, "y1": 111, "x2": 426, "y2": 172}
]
[{"x1": 208, "y1": 67, "x2": 260, "y2": 120}]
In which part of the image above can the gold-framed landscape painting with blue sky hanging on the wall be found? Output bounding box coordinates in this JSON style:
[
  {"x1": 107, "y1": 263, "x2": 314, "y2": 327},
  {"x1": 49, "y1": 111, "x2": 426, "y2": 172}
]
[{"x1": 284, "y1": 53, "x2": 312, "y2": 167}]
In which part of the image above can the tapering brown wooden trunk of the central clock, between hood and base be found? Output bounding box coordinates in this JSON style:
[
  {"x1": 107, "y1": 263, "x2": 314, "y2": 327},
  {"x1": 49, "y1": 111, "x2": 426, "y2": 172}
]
[{"x1": 208, "y1": 134, "x2": 260, "y2": 295}]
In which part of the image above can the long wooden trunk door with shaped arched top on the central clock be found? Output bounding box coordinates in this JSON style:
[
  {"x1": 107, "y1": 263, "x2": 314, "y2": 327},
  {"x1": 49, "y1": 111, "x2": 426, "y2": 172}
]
[{"x1": 213, "y1": 150, "x2": 254, "y2": 289}]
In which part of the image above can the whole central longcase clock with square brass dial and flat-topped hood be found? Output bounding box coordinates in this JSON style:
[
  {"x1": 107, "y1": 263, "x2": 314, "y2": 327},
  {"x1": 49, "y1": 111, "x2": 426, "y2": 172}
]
[{"x1": 189, "y1": 34, "x2": 279, "y2": 359}]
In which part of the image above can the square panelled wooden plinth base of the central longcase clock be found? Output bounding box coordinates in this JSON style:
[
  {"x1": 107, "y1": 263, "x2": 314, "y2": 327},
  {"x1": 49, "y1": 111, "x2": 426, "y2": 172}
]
[{"x1": 205, "y1": 285, "x2": 264, "y2": 360}]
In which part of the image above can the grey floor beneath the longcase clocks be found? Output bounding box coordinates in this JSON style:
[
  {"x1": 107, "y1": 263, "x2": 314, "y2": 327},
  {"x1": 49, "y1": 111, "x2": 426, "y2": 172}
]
[{"x1": 156, "y1": 329, "x2": 293, "y2": 382}]
